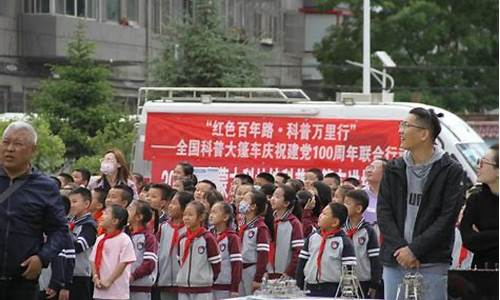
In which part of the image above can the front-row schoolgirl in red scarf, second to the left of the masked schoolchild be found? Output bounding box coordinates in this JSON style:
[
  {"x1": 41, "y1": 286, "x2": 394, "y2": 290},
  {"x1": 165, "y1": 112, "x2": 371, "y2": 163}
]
[{"x1": 176, "y1": 201, "x2": 221, "y2": 300}]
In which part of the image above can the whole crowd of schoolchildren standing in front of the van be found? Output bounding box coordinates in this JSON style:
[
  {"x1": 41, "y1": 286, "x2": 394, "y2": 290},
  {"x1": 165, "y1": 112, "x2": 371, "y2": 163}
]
[{"x1": 40, "y1": 158, "x2": 472, "y2": 300}]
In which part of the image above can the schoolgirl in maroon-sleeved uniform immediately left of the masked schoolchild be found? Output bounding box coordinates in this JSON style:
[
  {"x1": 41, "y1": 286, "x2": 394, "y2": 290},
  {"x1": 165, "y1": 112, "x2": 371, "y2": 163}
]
[{"x1": 209, "y1": 202, "x2": 243, "y2": 300}]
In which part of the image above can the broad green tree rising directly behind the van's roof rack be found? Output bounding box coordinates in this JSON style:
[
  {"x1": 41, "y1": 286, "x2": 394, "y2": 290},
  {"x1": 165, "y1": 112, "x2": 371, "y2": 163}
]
[{"x1": 151, "y1": 2, "x2": 262, "y2": 87}]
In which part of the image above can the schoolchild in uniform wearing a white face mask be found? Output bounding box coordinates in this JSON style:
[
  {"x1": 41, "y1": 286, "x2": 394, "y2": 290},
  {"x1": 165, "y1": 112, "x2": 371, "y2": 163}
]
[{"x1": 238, "y1": 189, "x2": 270, "y2": 296}]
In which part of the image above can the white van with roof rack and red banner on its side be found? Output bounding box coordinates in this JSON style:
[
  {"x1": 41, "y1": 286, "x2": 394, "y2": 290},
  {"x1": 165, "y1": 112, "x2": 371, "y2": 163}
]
[{"x1": 133, "y1": 88, "x2": 487, "y2": 187}]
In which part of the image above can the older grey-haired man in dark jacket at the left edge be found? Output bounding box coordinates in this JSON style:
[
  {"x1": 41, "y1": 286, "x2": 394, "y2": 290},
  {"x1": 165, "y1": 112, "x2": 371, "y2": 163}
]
[{"x1": 0, "y1": 121, "x2": 68, "y2": 300}]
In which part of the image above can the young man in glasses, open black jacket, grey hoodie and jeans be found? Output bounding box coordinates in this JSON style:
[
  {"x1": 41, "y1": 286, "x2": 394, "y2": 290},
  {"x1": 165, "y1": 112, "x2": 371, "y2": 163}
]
[{"x1": 377, "y1": 108, "x2": 465, "y2": 300}]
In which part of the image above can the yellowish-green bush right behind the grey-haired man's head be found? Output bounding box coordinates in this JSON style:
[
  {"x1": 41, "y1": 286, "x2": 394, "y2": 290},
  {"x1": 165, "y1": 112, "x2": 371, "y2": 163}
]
[{"x1": 0, "y1": 117, "x2": 66, "y2": 173}]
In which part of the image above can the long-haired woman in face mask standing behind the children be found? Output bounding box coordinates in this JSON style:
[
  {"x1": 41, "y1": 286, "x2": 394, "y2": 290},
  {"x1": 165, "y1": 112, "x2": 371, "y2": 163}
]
[{"x1": 89, "y1": 149, "x2": 139, "y2": 199}]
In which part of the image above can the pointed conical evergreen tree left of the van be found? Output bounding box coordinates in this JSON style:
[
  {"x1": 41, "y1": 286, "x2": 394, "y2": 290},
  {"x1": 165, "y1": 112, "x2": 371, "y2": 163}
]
[{"x1": 34, "y1": 22, "x2": 122, "y2": 160}]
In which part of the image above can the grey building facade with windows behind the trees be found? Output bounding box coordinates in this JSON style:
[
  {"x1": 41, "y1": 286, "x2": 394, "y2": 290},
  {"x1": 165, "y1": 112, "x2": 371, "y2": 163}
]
[{"x1": 0, "y1": 0, "x2": 348, "y2": 113}]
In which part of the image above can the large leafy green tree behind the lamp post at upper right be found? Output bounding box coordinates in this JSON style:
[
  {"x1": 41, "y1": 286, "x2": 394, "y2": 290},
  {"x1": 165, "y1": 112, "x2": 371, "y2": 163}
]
[{"x1": 314, "y1": 0, "x2": 498, "y2": 111}]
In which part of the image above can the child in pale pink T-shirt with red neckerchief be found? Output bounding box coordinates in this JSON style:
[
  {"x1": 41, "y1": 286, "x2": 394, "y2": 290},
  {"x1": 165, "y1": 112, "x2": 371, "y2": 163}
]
[{"x1": 90, "y1": 204, "x2": 136, "y2": 299}]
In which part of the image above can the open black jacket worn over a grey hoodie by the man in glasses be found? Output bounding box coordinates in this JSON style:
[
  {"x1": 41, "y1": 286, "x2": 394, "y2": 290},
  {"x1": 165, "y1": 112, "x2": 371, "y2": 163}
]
[{"x1": 377, "y1": 153, "x2": 466, "y2": 266}]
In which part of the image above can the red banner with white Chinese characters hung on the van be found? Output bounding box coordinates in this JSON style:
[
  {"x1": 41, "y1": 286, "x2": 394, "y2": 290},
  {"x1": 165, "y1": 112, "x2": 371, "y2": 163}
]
[{"x1": 144, "y1": 113, "x2": 399, "y2": 190}]
